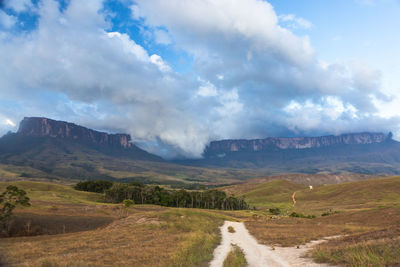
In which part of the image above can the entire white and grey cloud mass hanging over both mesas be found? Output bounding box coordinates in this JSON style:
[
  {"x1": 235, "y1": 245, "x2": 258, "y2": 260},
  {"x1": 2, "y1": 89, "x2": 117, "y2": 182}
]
[{"x1": 0, "y1": 0, "x2": 396, "y2": 157}]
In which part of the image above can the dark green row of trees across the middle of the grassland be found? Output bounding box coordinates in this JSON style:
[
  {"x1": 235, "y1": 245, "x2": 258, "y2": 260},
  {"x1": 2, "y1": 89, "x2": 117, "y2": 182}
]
[{"x1": 75, "y1": 181, "x2": 249, "y2": 210}]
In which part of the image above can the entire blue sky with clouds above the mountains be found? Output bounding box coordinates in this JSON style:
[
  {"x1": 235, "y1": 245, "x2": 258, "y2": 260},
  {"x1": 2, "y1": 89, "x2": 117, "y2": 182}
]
[{"x1": 0, "y1": 0, "x2": 400, "y2": 158}]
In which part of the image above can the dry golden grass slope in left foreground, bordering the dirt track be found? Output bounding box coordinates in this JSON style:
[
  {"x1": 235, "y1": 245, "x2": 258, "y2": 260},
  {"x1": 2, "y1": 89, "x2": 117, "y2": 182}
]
[{"x1": 0, "y1": 206, "x2": 228, "y2": 266}]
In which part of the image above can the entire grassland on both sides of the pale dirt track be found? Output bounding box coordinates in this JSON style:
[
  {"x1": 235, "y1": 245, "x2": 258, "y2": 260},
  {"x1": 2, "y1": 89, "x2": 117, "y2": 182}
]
[{"x1": 0, "y1": 177, "x2": 400, "y2": 266}]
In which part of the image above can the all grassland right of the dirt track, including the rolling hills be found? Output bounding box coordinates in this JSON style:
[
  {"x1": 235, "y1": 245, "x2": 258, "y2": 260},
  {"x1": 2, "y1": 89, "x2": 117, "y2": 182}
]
[{"x1": 223, "y1": 177, "x2": 400, "y2": 266}]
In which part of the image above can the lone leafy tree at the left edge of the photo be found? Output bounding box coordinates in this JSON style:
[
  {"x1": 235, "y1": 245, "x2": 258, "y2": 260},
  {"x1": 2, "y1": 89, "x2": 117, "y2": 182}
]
[{"x1": 0, "y1": 185, "x2": 31, "y2": 234}]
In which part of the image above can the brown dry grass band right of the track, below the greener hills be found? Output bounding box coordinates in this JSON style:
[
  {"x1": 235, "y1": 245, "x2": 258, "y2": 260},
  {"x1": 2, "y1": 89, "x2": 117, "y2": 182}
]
[{"x1": 245, "y1": 208, "x2": 400, "y2": 246}]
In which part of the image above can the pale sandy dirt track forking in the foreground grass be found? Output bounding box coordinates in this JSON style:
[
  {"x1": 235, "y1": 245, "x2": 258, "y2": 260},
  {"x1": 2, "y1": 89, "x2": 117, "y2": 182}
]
[{"x1": 210, "y1": 221, "x2": 328, "y2": 267}]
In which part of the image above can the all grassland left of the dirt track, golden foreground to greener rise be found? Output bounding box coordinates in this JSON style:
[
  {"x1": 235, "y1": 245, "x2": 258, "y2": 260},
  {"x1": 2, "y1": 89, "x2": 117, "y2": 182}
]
[{"x1": 0, "y1": 181, "x2": 241, "y2": 266}]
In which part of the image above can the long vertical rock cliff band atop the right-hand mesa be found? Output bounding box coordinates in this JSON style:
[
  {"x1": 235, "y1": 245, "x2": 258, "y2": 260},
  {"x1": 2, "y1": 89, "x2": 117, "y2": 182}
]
[{"x1": 204, "y1": 132, "x2": 391, "y2": 156}]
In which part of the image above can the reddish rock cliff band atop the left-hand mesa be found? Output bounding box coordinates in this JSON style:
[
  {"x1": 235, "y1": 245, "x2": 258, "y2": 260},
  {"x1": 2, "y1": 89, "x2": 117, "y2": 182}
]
[{"x1": 17, "y1": 117, "x2": 135, "y2": 149}]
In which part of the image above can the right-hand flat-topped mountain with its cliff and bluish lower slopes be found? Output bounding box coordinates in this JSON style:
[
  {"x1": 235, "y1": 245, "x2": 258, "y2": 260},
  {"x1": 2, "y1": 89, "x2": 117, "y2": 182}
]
[{"x1": 180, "y1": 132, "x2": 400, "y2": 174}]
